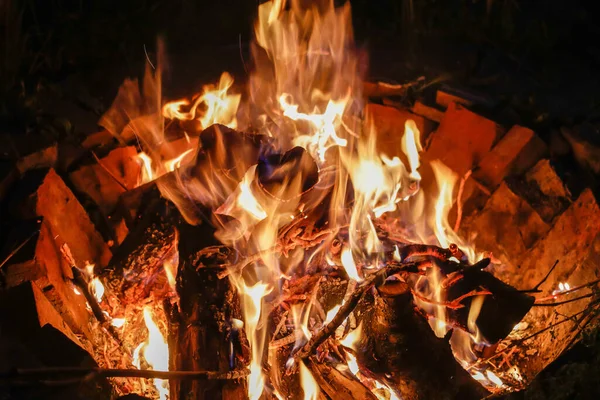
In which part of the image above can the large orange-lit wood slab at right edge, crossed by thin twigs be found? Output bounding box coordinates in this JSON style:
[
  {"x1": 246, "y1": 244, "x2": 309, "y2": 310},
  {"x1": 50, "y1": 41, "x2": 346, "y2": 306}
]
[{"x1": 503, "y1": 189, "x2": 600, "y2": 382}]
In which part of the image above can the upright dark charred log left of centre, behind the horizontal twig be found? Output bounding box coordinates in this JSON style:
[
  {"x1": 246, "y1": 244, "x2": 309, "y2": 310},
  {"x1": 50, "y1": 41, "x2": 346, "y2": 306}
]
[{"x1": 169, "y1": 223, "x2": 247, "y2": 400}]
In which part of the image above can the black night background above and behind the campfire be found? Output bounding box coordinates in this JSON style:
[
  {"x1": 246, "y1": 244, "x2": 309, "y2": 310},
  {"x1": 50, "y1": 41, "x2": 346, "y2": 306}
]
[{"x1": 0, "y1": 0, "x2": 600, "y2": 141}]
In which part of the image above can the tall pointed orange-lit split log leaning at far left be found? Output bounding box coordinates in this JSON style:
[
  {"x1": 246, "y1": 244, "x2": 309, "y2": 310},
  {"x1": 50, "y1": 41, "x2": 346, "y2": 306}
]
[{"x1": 2, "y1": 170, "x2": 110, "y2": 338}]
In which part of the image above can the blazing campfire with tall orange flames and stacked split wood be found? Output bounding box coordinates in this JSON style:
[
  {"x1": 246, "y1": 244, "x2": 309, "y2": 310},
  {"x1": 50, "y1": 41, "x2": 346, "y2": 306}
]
[{"x1": 0, "y1": 0, "x2": 600, "y2": 400}]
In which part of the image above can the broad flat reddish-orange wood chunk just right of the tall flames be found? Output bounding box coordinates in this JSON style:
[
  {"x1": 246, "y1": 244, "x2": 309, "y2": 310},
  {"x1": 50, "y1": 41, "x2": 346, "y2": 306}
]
[{"x1": 424, "y1": 103, "x2": 504, "y2": 176}]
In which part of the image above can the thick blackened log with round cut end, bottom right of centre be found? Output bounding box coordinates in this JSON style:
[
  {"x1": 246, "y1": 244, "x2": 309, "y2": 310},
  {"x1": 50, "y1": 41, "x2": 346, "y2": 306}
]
[{"x1": 356, "y1": 292, "x2": 486, "y2": 400}]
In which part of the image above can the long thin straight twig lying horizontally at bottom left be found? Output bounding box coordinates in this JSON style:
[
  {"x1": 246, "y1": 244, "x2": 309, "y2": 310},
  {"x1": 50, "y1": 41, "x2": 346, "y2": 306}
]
[{"x1": 0, "y1": 367, "x2": 249, "y2": 385}]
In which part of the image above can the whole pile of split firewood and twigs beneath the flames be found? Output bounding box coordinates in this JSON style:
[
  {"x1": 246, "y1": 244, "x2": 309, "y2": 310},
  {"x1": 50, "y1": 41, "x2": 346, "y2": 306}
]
[{"x1": 0, "y1": 85, "x2": 600, "y2": 399}]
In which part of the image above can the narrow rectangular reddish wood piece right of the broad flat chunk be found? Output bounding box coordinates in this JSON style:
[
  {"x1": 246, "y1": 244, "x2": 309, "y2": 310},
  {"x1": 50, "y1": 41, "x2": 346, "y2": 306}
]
[{"x1": 473, "y1": 125, "x2": 547, "y2": 190}]
